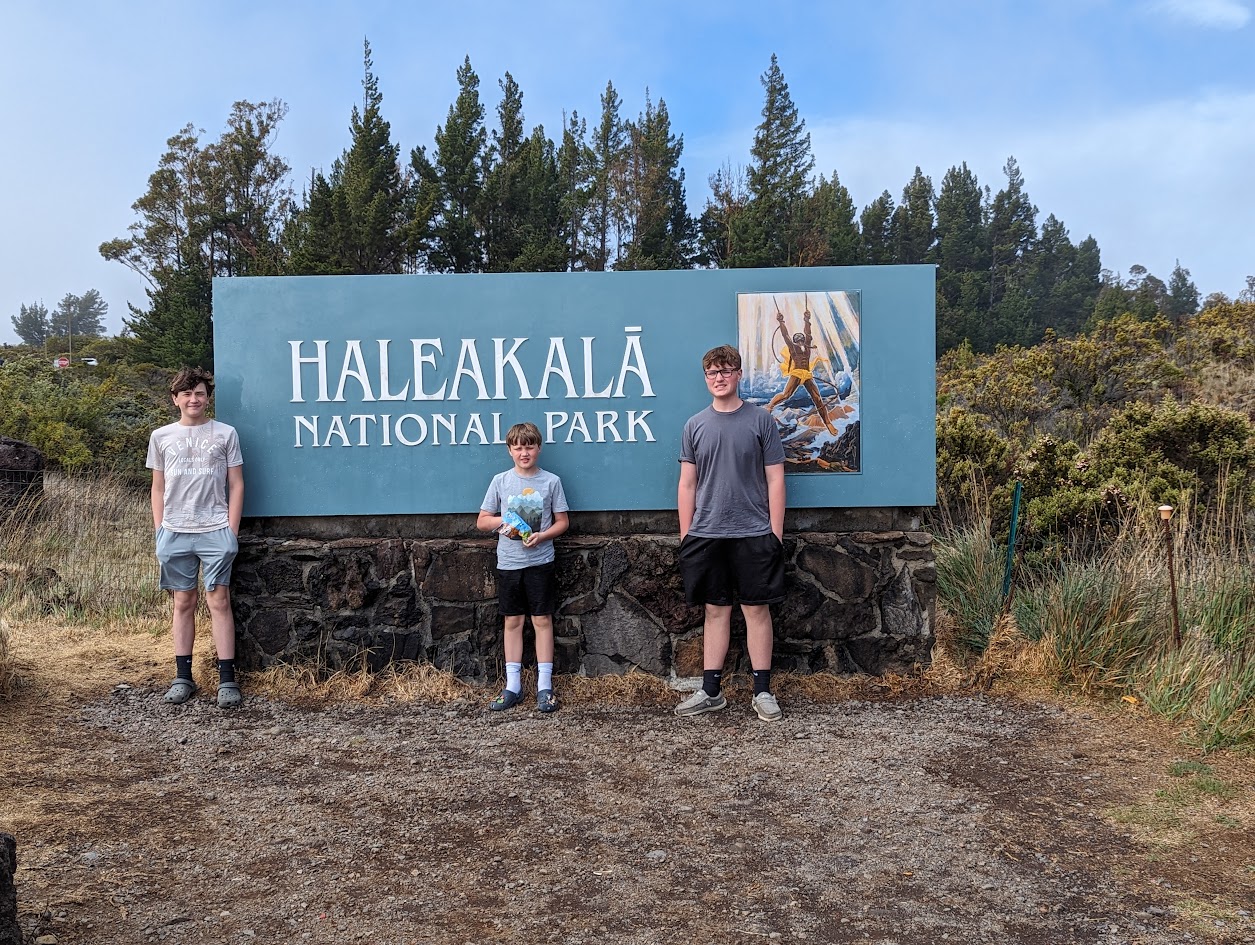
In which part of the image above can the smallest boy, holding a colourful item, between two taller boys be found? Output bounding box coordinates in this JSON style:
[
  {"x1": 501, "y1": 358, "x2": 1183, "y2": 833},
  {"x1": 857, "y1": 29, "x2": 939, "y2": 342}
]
[{"x1": 476, "y1": 423, "x2": 569, "y2": 712}]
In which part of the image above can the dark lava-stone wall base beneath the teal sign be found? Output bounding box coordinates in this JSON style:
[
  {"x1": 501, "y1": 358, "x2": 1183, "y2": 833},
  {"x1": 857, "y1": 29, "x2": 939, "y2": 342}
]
[{"x1": 232, "y1": 510, "x2": 936, "y2": 683}]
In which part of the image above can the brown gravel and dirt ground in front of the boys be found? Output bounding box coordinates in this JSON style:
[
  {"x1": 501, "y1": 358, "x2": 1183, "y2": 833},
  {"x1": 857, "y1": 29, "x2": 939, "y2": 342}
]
[{"x1": 0, "y1": 685, "x2": 1255, "y2": 945}]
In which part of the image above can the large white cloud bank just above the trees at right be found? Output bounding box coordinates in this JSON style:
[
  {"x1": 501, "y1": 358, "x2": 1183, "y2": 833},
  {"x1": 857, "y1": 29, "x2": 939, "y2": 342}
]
[{"x1": 811, "y1": 92, "x2": 1255, "y2": 295}]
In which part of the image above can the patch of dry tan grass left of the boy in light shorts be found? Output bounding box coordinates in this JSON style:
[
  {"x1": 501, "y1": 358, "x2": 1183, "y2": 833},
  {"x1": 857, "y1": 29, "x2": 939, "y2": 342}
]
[{"x1": 0, "y1": 476, "x2": 164, "y2": 624}]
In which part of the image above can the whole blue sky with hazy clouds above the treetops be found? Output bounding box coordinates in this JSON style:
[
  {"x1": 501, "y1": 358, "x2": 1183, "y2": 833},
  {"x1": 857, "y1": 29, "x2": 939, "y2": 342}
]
[{"x1": 0, "y1": 0, "x2": 1255, "y2": 341}]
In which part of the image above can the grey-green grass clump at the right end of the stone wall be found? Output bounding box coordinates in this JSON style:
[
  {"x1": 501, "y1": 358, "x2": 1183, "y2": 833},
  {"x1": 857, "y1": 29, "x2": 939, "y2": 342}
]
[{"x1": 936, "y1": 518, "x2": 1005, "y2": 654}]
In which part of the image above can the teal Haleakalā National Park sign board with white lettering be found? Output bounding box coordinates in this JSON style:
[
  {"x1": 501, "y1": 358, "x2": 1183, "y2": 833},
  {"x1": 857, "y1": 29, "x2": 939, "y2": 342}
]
[{"x1": 213, "y1": 266, "x2": 936, "y2": 516}]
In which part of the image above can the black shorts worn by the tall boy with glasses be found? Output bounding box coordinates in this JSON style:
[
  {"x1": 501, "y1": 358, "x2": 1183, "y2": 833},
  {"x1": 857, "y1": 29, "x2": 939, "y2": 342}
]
[{"x1": 680, "y1": 532, "x2": 784, "y2": 606}]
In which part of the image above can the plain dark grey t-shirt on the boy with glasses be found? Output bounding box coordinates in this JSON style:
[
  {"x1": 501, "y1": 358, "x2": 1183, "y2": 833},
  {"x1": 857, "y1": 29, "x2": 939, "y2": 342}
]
[{"x1": 680, "y1": 403, "x2": 784, "y2": 538}]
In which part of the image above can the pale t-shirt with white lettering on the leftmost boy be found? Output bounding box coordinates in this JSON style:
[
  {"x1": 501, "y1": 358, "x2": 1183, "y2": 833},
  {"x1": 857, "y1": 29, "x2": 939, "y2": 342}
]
[{"x1": 146, "y1": 420, "x2": 243, "y2": 532}]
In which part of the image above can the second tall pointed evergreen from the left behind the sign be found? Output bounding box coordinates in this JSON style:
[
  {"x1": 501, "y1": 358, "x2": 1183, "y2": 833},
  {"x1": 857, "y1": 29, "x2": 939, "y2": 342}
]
[{"x1": 410, "y1": 56, "x2": 488, "y2": 272}]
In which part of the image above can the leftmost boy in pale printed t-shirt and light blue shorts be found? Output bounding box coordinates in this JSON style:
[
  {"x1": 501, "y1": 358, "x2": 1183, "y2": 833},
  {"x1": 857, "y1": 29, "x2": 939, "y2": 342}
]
[{"x1": 147, "y1": 368, "x2": 243, "y2": 709}]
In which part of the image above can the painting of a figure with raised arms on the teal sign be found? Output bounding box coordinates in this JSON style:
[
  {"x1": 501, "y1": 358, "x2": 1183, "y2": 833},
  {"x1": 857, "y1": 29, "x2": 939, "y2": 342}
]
[{"x1": 737, "y1": 291, "x2": 862, "y2": 474}]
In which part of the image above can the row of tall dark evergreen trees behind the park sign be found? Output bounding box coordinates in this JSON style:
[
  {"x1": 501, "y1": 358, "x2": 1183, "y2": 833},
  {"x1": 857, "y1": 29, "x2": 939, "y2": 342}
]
[{"x1": 56, "y1": 41, "x2": 1224, "y2": 366}]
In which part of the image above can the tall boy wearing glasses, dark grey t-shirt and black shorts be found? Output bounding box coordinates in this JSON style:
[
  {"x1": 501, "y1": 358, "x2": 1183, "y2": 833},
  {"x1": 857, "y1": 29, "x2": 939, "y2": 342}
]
[{"x1": 675, "y1": 345, "x2": 784, "y2": 722}]
